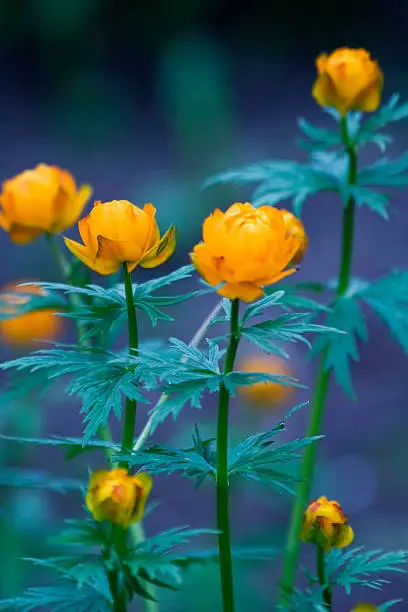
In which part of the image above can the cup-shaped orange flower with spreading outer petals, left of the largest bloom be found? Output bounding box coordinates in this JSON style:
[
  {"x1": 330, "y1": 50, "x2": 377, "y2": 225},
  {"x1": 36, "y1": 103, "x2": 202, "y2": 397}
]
[{"x1": 65, "y1": 200, "x2": 176, "y2": 274}]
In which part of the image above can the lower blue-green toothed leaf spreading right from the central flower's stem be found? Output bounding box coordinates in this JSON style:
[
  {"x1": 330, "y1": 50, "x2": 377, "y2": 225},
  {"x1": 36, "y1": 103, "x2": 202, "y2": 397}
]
[{"x1": 228, "y1": 404, "x2": 322, "y2": 495}]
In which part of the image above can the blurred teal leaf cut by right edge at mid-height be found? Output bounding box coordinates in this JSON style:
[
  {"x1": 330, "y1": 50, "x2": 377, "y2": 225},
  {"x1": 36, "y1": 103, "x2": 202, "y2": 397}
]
[{"x1": 358, "y1": 270, "x2": 408, "y2": 353}]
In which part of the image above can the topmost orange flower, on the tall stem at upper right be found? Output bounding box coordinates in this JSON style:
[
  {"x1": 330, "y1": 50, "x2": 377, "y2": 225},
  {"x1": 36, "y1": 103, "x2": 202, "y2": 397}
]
[{"x1": 312, "y1": 47, "x2": 384, "y2": 116}]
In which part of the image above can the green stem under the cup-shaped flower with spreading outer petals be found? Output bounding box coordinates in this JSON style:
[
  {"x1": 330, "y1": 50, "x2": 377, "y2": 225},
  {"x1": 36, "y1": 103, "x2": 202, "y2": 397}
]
[{"x1": 121, "y1": 263, "x2": 139, "y2": 468}]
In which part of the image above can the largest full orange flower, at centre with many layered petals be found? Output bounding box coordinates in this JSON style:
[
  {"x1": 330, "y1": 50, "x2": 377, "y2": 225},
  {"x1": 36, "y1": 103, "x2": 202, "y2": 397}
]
[{"x1": 191, "y1": 203, "x2": 299, "y2": 302}]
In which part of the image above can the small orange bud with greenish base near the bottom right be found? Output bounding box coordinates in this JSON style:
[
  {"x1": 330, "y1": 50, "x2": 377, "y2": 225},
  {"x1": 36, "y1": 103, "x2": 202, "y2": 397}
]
[{"x1": 300, "y1": 497, "x2": 354, "y2": 552}]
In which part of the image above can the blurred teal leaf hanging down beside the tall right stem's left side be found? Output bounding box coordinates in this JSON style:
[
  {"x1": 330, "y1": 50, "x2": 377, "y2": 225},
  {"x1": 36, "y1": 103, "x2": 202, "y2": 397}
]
[{"x1": 312, "y1": 296, "x2": 368, "y2": 398}]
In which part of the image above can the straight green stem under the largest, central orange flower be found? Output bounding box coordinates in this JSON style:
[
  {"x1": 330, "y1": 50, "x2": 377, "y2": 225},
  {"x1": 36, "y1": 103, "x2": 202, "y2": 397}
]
[{"x1": 217, "y1": 300, "x2": 239, "y2": 612}]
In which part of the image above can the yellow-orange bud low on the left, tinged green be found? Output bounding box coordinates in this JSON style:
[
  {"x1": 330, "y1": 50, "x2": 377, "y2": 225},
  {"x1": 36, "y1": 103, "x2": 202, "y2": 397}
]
[{"x1": 86, "y1": 468, "x2": 152, "y2": 529}]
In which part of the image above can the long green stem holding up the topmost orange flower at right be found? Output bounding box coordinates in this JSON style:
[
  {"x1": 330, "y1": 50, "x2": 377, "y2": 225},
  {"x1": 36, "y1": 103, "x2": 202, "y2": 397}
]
[{"x1": 280, "y1": 113, "x2": 357, "y2": 603}]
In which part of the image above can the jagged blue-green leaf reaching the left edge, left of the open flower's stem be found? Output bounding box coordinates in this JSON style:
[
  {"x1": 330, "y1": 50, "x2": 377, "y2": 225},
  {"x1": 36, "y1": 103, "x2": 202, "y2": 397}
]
[{"x1": 0, "y1": 345, "x2": 148, "y2": 442}]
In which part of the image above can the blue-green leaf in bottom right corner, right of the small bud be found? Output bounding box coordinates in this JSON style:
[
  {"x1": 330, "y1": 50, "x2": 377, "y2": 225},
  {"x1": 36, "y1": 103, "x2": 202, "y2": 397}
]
[{"x1": 326, "y1": 547, "x2": 408, "y2": 593}]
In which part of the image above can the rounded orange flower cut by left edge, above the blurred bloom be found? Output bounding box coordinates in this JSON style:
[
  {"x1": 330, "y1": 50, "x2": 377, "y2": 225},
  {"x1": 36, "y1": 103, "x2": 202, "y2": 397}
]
[{"x1": 0, "y1": 164, "x2": 91, "y2": 244}]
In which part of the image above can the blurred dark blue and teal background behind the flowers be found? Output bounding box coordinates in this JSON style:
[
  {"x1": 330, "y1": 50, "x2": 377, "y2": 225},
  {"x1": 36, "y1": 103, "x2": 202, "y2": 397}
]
[{"x1": 0, "y1": 0, "x2": 408, "y2": 612}]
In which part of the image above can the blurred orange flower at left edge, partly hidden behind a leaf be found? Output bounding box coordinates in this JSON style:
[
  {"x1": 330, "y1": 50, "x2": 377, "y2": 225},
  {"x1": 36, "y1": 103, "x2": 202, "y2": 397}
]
[{"x1": 0, "y1": 285, "x2": 62, "y2": 347}]
